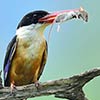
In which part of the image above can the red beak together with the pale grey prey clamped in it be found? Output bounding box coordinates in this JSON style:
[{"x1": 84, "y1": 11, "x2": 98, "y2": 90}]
[{"x1": 39, "y1": 7, "x2": 88, "y2": 24}]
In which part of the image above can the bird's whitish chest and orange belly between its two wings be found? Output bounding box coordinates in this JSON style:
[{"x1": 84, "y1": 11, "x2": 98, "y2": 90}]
[{"x1": 10, "y1": 27, "x2": 46, "y2": 85}]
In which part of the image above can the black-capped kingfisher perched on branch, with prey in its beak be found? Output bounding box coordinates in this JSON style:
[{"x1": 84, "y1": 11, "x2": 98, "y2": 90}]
[{"x1": 3, "y1": 6, "x2": 87, "y2": 88}]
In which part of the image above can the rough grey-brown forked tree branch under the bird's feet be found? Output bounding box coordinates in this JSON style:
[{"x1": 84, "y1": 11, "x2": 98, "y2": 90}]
[{"x1": 0, "y1": 69, "x2": 100, "y2": 100}]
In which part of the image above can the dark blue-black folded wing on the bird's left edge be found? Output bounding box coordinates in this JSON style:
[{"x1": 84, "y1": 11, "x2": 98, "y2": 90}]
[{"x1": 3, "y1": 36, "x2": 17, "y2": 86}]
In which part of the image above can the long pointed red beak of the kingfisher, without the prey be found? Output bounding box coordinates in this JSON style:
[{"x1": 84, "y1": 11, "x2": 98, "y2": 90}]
[{"x1": 39, "y1": 9, "x2": 78, "y2": 24}]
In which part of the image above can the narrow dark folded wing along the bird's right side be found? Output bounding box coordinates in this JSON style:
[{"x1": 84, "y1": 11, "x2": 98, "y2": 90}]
[{"x1": 37, "y1": 41, "x2": 48, "y2": 80}]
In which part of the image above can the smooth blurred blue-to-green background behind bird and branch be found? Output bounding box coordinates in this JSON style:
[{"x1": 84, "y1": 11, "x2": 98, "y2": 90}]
[{"x1": 0, "y1": 0, "x2": 100, "y2": 100}]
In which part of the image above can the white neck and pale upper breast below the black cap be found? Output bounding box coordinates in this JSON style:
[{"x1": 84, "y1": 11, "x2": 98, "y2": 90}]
[{"x1": 16, "y1": 26, "x2": 45, "y2": 60}]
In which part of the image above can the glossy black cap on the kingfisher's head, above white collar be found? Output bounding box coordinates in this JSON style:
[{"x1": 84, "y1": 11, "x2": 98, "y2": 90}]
[{"x1": 17, "y1": 10, "x2": 49, "y2": 29}]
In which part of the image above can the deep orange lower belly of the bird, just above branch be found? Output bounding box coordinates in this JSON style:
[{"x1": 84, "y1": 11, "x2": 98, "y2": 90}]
[{"x1": 10, "y1": 57, "x2": 41, "y2": 86}]
